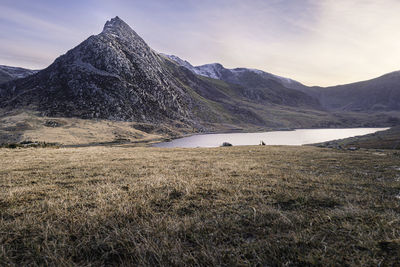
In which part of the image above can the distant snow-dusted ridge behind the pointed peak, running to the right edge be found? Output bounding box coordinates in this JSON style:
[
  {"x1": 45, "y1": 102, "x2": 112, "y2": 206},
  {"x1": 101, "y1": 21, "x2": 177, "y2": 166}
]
[{"x1": 168, "y1": 55, "x2": 400, "y2": 112}]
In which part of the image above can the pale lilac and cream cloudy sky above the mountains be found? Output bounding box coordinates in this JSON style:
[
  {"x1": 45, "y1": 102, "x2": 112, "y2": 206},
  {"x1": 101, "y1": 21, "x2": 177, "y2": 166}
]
[{"x1": 0, "y1": 0, "x2": 400, "y2": 86}]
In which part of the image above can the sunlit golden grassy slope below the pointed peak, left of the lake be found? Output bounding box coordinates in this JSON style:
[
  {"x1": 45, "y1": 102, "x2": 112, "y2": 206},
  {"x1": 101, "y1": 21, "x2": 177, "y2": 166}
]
[{"x1": 0, "y1": 110, "x2": 178, "y2": 145}]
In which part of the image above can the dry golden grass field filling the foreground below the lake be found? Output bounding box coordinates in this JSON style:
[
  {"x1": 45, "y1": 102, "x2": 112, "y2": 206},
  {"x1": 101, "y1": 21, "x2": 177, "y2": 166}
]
[{"x1": 0, "y1": 146, "x2": 400, "y2": 266}]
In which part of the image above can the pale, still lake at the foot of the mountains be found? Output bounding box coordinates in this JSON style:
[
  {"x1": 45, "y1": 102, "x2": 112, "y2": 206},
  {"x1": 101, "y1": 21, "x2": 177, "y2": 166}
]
[{"x1": 154, "y1": 128, "x2": 389, "y2": 148}]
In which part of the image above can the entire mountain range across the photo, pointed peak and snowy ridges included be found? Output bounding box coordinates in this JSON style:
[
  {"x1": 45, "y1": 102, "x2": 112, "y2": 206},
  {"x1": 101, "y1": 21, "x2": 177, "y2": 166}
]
[{"x1": 0, "y1": 17, "x2": 400, "y2": 131}]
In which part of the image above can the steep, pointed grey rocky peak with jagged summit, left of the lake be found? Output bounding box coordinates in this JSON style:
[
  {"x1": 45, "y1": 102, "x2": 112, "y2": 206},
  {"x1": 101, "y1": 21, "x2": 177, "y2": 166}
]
[{"x1": 0, "y1": 17, "x2": 192, "y2": 122}]
